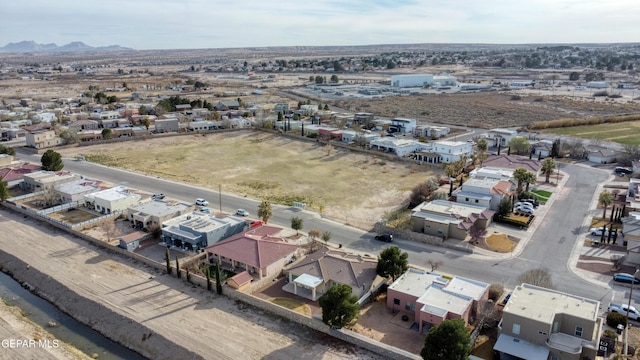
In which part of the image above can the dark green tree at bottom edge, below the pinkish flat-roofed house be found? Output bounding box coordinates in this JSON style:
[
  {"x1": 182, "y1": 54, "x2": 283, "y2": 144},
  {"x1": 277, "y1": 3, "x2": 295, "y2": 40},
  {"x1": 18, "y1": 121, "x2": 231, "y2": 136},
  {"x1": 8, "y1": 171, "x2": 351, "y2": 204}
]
[{"x1": 420, "y1": 319, "x2": 471, "y2": 360}]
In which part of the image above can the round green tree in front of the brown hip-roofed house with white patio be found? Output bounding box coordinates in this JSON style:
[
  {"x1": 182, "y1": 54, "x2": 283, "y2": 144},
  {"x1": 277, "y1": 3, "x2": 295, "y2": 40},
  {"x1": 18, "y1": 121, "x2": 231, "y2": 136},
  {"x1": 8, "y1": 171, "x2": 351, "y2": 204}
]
[{"x1": 318, "y1": 284, "x2": 360, "y2": 329}]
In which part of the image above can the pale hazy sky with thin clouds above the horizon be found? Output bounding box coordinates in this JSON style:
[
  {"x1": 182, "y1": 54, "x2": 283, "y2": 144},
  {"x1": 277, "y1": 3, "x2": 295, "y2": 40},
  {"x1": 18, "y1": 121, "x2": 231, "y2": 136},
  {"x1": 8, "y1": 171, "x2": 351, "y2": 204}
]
[{"x1": 0, "y1": 0, "x2": 640, "y2": 50}]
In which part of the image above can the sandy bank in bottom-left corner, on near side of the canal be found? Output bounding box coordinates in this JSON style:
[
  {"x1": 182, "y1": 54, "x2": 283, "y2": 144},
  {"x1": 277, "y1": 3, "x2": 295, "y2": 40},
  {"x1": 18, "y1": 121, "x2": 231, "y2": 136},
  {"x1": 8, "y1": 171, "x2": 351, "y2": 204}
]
[{"x1": 0, "y1": 302, "x2": 90, "y2": 360}]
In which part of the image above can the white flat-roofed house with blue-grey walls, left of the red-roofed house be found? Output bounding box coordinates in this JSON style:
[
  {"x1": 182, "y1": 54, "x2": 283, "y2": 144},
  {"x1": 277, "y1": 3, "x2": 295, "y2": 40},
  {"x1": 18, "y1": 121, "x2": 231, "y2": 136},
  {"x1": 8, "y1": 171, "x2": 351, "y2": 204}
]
[{"x1": 162, "y1": 211, "x2": 247, "y2": 252}]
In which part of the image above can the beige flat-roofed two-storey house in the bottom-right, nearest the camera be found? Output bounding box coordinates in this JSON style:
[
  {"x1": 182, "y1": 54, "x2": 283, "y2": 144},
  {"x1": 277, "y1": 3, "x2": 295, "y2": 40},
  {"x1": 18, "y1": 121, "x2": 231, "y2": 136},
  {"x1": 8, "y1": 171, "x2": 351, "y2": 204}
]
[{"x1": 493, "y1": 284, "x2": 603, "y2": 360}]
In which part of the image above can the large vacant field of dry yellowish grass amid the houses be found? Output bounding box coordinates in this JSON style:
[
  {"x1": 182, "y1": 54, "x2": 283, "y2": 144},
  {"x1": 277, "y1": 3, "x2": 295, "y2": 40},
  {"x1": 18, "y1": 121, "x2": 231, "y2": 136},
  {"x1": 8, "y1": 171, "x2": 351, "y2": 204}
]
[{"x1": 60, "y1": 131, "x2": 442, "y2": 230}]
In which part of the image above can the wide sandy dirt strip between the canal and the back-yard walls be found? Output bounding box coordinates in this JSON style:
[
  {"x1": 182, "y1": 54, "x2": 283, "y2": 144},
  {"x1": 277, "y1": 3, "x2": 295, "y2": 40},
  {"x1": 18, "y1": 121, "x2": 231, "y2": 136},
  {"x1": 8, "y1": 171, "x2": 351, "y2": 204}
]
[{"x1": 0, "y1": 210, "x2": 379, "y2": 359}]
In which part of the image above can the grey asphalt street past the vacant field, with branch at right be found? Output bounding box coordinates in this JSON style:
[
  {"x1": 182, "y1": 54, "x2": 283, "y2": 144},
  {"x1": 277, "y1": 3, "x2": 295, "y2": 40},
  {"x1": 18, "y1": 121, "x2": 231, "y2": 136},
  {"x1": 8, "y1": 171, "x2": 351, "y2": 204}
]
[{"x1": 20, "y1": 148, "x2": 612, "y2": 302}]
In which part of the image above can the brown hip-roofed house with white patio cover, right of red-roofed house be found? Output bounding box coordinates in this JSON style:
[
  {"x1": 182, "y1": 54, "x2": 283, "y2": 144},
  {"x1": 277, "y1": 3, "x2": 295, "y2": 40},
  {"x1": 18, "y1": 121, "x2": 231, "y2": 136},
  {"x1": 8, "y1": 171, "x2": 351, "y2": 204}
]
[{"x1": 283, "y1": 247, "x2": 380, "y2": 301}]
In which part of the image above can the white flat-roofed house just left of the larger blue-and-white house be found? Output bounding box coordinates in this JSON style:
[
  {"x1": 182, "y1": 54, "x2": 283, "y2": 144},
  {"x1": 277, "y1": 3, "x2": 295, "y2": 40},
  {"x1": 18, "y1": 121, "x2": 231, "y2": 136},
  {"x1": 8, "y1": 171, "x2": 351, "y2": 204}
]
[{"x1": 127, "y1": 200, "x2": 193, "y2": 230}]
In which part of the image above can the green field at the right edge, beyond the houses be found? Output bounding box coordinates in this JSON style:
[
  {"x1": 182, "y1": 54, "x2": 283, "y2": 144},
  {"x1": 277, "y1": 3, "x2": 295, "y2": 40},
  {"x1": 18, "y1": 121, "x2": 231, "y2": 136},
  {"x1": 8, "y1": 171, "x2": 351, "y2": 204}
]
[{"x1": 541, "y1": 121, "x2": 640, "y2": 145}]
